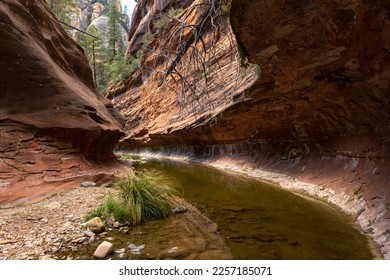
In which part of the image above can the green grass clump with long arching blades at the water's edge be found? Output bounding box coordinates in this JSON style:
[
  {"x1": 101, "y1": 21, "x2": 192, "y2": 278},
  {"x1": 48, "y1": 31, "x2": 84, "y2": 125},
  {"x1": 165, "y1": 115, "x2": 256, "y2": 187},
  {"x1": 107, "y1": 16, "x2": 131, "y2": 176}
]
[{"x1": 84, "y1": 171, "x2": 180, "y2": 225}]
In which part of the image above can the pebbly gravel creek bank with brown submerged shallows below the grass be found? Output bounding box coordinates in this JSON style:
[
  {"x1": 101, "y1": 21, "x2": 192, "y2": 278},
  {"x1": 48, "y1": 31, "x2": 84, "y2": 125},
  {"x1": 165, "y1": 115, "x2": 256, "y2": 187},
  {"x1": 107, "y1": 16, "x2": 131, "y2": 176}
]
[{"x1": 0, "y1": 184, "x2": 233, "y2": 260}]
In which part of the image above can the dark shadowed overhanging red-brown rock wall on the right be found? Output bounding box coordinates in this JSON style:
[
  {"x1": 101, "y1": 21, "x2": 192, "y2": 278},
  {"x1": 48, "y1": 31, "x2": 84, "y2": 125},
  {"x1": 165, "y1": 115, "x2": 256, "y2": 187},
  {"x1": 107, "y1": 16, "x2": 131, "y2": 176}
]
[{"x1": 229, "y1": 0, "x2": 390, "y2": 257}]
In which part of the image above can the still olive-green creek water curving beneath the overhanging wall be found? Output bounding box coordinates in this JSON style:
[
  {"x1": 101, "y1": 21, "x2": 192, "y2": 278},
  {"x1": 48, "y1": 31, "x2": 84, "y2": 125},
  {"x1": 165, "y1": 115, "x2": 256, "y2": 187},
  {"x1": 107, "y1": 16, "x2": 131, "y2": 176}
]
[{"x1": 137, "y1": 160, "x2": 374, "y2": 259}]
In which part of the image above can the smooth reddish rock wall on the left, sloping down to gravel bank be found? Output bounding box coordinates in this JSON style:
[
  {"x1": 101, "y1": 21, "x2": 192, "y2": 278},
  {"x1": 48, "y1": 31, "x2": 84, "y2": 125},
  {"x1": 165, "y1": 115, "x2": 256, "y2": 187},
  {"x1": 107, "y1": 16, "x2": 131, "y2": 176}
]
[{"x1": 0, "y1": 0, "x2": 122, "y2": 206}]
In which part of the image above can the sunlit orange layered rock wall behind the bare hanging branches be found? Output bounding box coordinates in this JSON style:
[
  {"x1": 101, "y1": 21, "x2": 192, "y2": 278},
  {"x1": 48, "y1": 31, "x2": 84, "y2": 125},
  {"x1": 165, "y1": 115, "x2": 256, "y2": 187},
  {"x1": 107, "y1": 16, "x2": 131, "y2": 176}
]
[{"x1": 108, "y1": 0, "x2": 259, "y2": 146}]
